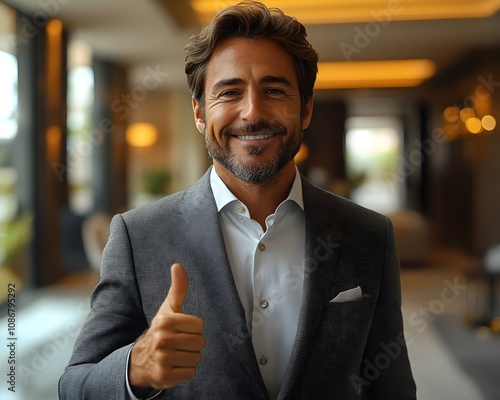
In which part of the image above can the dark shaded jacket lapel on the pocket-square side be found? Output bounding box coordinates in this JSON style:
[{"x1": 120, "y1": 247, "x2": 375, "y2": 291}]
[{"x1": 278, "y1": 178, "x2": 342, "y2": 400}]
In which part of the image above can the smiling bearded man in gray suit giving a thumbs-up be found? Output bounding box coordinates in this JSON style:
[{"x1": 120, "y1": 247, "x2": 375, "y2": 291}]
[{"x1": 60, "y1": 2, "x2": 416, "y2": 400}]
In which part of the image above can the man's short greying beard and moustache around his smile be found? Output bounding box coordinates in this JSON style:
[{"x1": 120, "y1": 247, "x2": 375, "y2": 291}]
[{"x1": 205, "y1": 122, "x2": 304, "y2": 183}]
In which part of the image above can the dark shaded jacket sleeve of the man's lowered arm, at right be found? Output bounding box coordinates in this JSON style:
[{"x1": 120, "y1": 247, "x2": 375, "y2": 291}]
[{"x1": 360, "y1": 218, "x2": 416, "y2": 400}]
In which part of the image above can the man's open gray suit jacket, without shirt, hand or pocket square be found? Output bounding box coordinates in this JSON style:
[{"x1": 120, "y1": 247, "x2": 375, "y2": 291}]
[{"x1": 59, "y1": 167, "x2": 416, "y2": 400}]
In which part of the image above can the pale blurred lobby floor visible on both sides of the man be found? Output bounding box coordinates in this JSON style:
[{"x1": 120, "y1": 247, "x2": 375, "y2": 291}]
[{"x1": 0, "y1": 252, "x2": 500, "y2": 400}]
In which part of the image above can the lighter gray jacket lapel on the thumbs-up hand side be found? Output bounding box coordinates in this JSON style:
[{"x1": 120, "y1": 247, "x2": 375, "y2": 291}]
[{"x1": 178, "y1": 170, "x2": 268, "y2": 399}]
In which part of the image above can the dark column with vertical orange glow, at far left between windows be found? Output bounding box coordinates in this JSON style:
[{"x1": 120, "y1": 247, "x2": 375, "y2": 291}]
[{"x1": 16, "y1": 14, "x2": 67, "y2": 287}]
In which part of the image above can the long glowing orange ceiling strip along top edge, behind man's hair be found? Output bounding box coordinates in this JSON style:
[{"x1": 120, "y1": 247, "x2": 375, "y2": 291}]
[{"x1": 190, "y1": 0, "x2": 500, "y2": 24}]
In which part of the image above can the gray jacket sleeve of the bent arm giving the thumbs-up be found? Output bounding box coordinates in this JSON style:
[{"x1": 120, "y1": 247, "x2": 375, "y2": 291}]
[{"x1": 59, "y1": 215, "x2": 148, "y2": 400}]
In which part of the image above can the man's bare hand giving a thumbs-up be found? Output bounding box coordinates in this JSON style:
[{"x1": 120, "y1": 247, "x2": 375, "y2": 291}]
[{"x1": 129, "y1": 264, "x2": 205, "y2": 395}]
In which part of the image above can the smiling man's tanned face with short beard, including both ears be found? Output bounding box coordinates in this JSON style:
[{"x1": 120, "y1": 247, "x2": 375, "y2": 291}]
[{"x1": 193, "y1": 38, "x2": 312, "y2": 182}]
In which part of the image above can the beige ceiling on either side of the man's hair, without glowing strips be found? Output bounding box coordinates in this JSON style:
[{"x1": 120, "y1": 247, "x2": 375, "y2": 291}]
[{"x1": 4, "y1": 0, "x2": 500, "y2": 87}]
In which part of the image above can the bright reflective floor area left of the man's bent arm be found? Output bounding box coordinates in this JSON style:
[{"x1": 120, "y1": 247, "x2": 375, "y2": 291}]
[{"x1": 0, "y1": 273, "x2": 98, "y2": 400}]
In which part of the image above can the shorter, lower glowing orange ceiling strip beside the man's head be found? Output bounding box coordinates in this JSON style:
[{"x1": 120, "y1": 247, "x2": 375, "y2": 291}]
[{"x1": 315, "y1": 59, "x2": 435, "y2": 89}]
